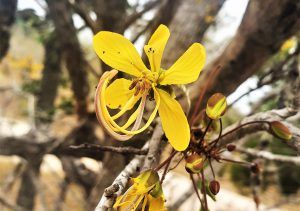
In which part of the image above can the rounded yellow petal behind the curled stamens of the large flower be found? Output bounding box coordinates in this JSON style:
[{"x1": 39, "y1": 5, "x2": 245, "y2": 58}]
[{"x1": 105, "y1": 78, "x2": 138, "y2": 109}]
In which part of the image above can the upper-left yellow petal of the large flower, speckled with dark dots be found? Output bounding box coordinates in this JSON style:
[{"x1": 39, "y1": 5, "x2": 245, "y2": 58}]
[{"x1": 93, "y1": 31, "x2": 149, "y2": 76}]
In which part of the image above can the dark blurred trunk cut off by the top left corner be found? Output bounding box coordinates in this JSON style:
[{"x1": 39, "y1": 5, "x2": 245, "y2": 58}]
[{"x1": 0, "y1": 0, "x2": 17, "y2": 61}]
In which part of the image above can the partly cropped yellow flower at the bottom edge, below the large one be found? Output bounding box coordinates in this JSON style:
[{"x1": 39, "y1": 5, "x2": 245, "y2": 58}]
[{"x1": 114, "y1": 170, "x2": 165, "y2": 211}]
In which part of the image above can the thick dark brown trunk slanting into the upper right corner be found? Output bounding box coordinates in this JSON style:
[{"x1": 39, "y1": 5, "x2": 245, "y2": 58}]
[{"x1": 191, "y1": 0, "x2": 300, "y2": 102}]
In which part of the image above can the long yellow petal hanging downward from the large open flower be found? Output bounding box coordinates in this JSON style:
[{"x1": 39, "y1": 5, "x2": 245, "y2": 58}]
[{"x1": 155, "y1": 89, "x2": 190, "y2": 151}]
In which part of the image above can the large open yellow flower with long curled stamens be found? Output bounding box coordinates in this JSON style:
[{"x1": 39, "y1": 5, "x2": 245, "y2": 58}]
[{"x1": 93, "y1": 25, "x2": 206, "y2": 151}]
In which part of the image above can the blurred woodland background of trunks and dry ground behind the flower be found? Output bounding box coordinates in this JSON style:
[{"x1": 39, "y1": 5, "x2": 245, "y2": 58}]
[{"x1": 0, "y1": 0, "x2": 300, "y2": 211}]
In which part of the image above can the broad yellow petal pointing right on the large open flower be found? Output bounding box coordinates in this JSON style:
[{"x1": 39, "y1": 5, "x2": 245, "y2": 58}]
[{"x1": 159, "y1": 43, "x2": 206, "y2": 85}]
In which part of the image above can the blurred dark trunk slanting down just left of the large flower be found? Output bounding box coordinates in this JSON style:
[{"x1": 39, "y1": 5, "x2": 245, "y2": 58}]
[{"x1": 47, "y1": 0, "x2": 89, "y2": 117}]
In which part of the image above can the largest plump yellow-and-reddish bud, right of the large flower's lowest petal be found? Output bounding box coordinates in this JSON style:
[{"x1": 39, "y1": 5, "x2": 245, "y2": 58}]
[{"x1": 206, "y1": 93, "x2": 227, "y2": 120}]
